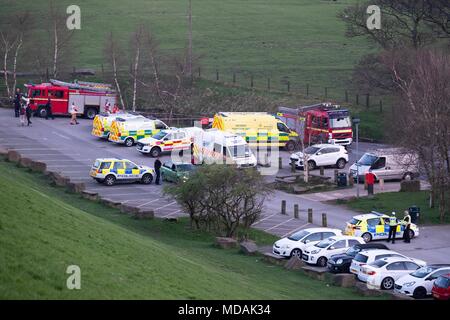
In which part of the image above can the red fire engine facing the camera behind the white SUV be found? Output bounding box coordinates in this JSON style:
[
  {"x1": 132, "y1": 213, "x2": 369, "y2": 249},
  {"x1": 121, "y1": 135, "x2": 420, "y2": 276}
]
[{"x1": 277, "y1": 103, "x2": 353, "y2": 145}]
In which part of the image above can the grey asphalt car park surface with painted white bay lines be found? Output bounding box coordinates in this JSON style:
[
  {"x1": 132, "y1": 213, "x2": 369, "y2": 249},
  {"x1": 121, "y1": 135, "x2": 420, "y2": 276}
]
[{"x1": 0, "y1": 109, "x2": 450, "y2": 263}]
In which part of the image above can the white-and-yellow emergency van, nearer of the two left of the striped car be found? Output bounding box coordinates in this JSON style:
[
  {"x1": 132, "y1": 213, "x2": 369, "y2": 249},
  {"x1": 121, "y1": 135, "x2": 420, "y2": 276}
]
[{"x1": 108, "y1": 117, "x2": 169, "y2": 147}]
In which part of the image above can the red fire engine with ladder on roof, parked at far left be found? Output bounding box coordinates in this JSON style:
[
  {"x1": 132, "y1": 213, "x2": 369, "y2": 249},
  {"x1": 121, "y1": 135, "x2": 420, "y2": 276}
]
[{"x1": 25, "y1": 80, "x2": 117, "y2": 119}]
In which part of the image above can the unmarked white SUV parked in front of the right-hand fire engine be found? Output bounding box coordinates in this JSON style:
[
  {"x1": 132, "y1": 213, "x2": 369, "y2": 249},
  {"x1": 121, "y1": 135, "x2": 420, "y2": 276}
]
[{"x1": 290, "y1": 144, "x2": 348, "y2": 170}]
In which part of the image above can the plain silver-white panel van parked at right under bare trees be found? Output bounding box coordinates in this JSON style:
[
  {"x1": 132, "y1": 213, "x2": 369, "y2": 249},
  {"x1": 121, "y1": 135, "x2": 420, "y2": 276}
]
[{"x1": 349, "y1": 148, "x2": 419, "y2": 181}]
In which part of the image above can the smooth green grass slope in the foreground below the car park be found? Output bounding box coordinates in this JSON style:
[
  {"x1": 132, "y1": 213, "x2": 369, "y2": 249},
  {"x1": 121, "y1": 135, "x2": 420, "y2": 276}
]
[{"x1": 0, "y1": 161, "x2": 380, "y2": 299}]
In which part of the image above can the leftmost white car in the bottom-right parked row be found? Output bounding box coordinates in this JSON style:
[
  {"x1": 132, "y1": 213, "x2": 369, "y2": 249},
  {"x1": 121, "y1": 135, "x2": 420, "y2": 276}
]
[{"x1": 273, "y1": 228, "x2": 342, "y2": 259}]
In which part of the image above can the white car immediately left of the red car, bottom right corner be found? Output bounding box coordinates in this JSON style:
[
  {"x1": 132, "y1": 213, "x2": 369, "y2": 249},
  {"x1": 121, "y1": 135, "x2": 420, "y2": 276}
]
[{"x1": 394, "y1": 264, "x2": 450, "y2": 299}]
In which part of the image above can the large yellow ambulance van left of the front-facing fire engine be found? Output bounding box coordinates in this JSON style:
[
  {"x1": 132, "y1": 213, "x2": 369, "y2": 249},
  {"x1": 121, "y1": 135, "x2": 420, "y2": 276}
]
[{"x1": 212, "y1": 112, "x2": 299, "y2": 151}]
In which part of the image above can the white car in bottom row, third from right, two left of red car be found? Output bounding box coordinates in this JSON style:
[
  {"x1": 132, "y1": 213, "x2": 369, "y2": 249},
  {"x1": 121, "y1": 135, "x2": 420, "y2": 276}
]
[{"x1": 362, "y1": 257, "x2": 420, "y2": 290}]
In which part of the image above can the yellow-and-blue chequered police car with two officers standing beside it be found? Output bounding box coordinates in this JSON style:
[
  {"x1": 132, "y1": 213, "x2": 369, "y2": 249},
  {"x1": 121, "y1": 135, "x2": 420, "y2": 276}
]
[{"x1": 344, "y1": 211, "x2": 419, "y2": 242}]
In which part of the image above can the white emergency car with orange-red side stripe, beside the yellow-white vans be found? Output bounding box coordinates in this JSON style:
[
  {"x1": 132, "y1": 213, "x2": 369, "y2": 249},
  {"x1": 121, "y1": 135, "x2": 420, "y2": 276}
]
[{"x1": 136, "y1": 129, "x2": 192, "y2": 157}]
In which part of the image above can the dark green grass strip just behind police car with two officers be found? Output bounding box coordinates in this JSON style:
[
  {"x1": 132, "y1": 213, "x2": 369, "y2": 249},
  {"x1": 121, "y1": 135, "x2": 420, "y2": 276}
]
[{"x1": 337, "y1": 191, "x2": 450, "y2": 224}]
